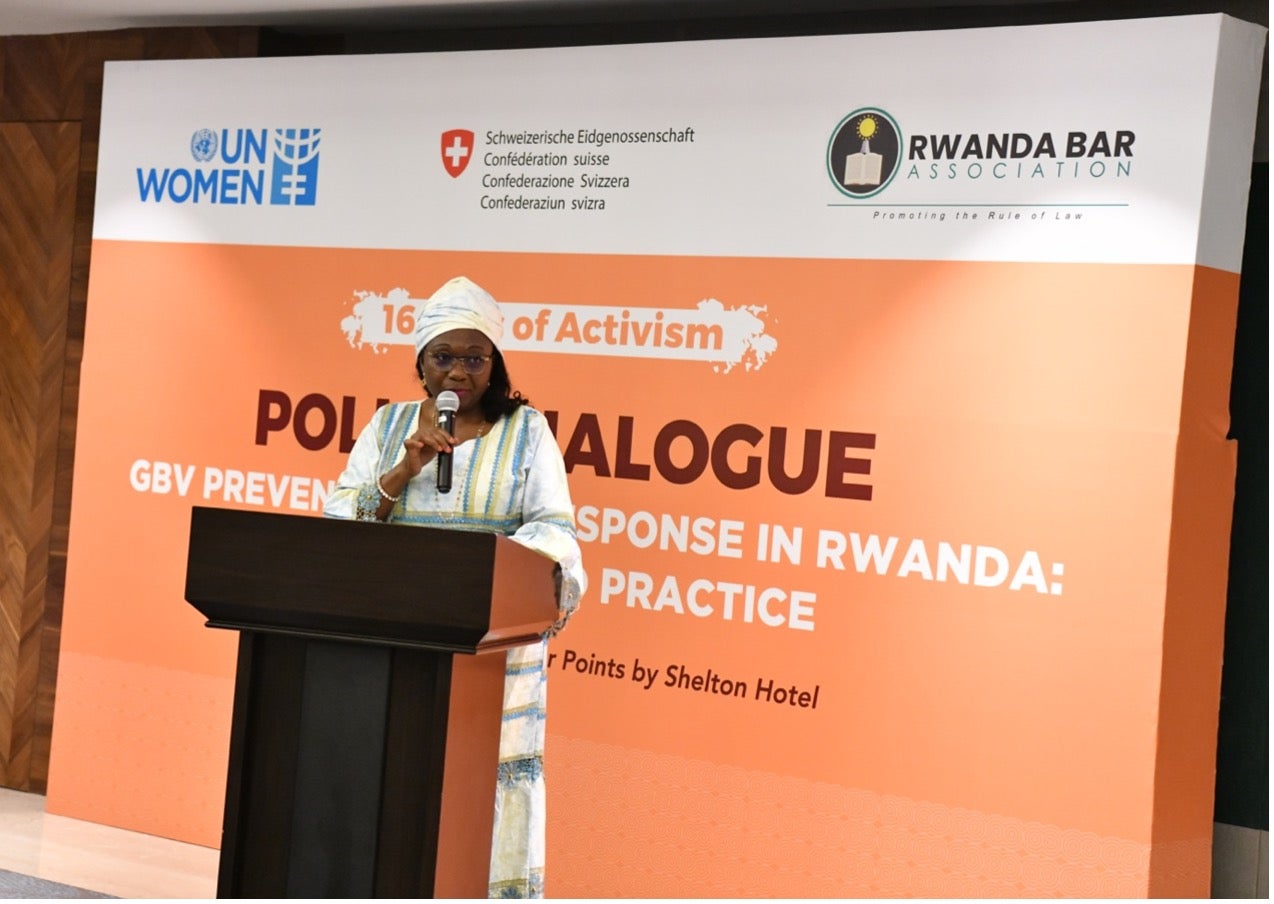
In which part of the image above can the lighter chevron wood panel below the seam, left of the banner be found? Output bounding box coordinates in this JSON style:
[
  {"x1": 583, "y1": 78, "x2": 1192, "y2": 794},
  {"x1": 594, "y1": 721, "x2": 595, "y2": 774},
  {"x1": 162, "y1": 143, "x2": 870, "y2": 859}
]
[{"x1": 0, "y1": 122, "x2": 80, "y2": 789}]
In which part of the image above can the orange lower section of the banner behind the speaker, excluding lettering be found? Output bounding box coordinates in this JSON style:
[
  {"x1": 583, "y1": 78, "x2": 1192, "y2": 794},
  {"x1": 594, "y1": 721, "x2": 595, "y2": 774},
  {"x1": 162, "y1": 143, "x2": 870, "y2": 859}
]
[{"x1": 48, "y1": 241, "x2": 1237, "y2": 896}]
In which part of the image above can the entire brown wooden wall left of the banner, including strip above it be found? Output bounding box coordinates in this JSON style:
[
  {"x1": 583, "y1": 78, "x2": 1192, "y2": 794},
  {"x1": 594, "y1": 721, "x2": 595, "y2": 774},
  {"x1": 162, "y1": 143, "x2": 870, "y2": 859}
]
[{"x1": 0, "y1": 28, "x2": 259, "y2": 792}]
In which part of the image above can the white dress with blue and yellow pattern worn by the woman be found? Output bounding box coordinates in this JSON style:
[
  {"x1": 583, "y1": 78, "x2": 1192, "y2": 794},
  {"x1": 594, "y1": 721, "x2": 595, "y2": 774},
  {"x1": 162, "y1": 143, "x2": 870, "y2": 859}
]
[{"x1": 324, "y1": 401, "x2": 586, "y2": 898}]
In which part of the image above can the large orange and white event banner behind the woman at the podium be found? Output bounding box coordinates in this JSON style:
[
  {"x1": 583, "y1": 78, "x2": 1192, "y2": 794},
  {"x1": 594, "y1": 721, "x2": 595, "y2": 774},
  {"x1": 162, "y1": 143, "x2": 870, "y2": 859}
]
[{"x1": 48, "y1": 15, "x2": 1265, "y2": 896}]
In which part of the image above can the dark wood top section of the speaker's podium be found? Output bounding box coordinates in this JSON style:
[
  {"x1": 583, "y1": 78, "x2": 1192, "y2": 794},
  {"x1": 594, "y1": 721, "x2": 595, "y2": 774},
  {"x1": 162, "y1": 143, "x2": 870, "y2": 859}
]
[{"x1": 186, "y1": 505, "x2": 558, "y2": 653}]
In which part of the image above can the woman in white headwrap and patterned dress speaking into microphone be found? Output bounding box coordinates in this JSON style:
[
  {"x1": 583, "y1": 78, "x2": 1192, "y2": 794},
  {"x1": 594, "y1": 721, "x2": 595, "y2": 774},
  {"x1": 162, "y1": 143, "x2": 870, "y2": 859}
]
[{"x1": 324, "y1": 276, "x2": 586, "y2": 898}]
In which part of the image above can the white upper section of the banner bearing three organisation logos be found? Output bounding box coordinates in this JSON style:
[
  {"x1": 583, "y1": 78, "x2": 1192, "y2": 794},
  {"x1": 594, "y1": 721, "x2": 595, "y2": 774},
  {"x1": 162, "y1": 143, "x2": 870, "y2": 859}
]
[{"x1": 94, "y1": 15, "x2": 1265, "y2": 271}]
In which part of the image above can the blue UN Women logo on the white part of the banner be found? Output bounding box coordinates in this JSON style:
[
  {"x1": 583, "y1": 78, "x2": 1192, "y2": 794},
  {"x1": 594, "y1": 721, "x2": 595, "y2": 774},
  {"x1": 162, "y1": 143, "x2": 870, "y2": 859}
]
[{"x1": 138, "y1": 129, "x2": 322, "y2": 206}]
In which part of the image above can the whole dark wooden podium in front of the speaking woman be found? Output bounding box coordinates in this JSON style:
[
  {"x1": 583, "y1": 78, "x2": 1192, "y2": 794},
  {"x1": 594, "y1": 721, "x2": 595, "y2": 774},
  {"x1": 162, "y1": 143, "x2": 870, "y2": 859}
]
[{"x1": 186, "y1": 507, "x2": 557, "y2": 898}]
